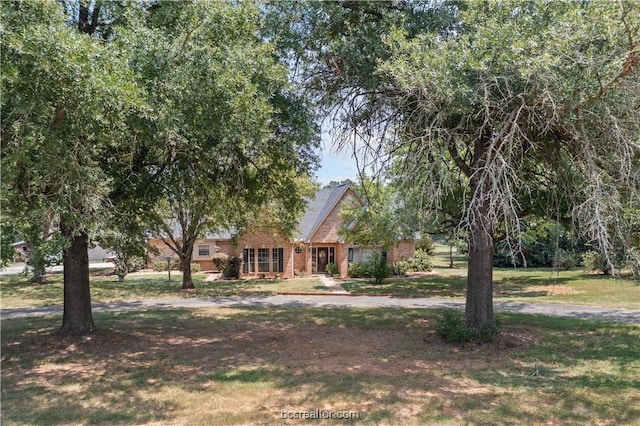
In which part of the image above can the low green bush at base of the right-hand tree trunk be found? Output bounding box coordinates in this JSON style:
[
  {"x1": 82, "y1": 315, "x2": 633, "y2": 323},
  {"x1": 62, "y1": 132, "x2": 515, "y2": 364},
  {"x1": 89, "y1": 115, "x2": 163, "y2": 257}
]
[{"x1": 436, "y1": 309, "x2": 499, "y2": 343}]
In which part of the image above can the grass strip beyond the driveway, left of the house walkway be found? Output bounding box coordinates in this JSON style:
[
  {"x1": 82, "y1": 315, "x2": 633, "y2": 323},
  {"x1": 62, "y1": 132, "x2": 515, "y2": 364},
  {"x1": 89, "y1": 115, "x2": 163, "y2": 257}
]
[{"x1": 0, "y1": 272, "x2": 327, "y2": 308}]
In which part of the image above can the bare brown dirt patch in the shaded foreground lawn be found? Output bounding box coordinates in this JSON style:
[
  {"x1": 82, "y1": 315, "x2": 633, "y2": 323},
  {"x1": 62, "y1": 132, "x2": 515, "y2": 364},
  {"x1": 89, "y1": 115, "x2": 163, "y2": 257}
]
[{"x1": 2, "y1": 315, "x2": 536, "y2": 377}]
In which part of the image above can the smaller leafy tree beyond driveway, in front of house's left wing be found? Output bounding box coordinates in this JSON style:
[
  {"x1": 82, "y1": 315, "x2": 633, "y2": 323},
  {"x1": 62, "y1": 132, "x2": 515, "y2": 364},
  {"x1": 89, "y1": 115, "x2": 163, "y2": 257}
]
[{"x1": 137, "y1": 2, "x2": 318, "y2": 289}]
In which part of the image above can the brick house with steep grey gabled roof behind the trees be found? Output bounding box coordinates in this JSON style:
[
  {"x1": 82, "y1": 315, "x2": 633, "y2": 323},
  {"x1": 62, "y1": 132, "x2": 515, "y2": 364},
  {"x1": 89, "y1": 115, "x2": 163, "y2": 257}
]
[{"x1": 149, "y1": 185, "x2": 415, "y2": 277}]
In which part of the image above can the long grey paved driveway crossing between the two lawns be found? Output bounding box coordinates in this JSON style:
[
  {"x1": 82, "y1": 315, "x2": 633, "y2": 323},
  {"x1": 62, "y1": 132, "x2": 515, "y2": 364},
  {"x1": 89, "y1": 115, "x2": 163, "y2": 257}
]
[{"x1": 0, "y1": 295, "x2": 640, "y2": 324}]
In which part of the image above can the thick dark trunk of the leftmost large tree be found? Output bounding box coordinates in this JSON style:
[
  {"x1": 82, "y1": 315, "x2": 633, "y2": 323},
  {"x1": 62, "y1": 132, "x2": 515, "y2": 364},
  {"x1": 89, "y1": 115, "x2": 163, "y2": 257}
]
[{"x1": 59, "y1": 224, "x2": 96, "y2": 336}]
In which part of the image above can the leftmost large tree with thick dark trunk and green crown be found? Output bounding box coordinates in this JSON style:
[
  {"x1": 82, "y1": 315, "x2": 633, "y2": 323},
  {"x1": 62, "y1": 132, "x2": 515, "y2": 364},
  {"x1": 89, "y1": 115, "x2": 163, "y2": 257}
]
[{"x1": 0, "y1": 2, "x2": 148, "y2": 335}]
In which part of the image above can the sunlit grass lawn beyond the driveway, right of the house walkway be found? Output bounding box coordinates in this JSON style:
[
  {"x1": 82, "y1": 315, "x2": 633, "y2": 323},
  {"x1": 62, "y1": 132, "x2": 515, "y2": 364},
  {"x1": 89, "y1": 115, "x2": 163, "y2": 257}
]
[{"x1": 342, "y1": 246, "x2": 640, "y2": 309}]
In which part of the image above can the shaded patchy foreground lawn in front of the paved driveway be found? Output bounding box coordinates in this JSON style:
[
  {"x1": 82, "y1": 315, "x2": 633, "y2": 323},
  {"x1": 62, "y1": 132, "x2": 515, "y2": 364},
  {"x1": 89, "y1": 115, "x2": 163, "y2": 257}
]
[{"x1": 1, "y1": 308, "x2": 640, "y2": 426}]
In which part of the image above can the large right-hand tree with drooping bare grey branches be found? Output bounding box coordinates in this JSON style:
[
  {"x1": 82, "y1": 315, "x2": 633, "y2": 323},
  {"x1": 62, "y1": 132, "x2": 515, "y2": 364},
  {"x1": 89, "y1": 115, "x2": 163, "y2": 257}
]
[{"x1": 272, "y1": 1, "x2": 640, "y2": 330}]
